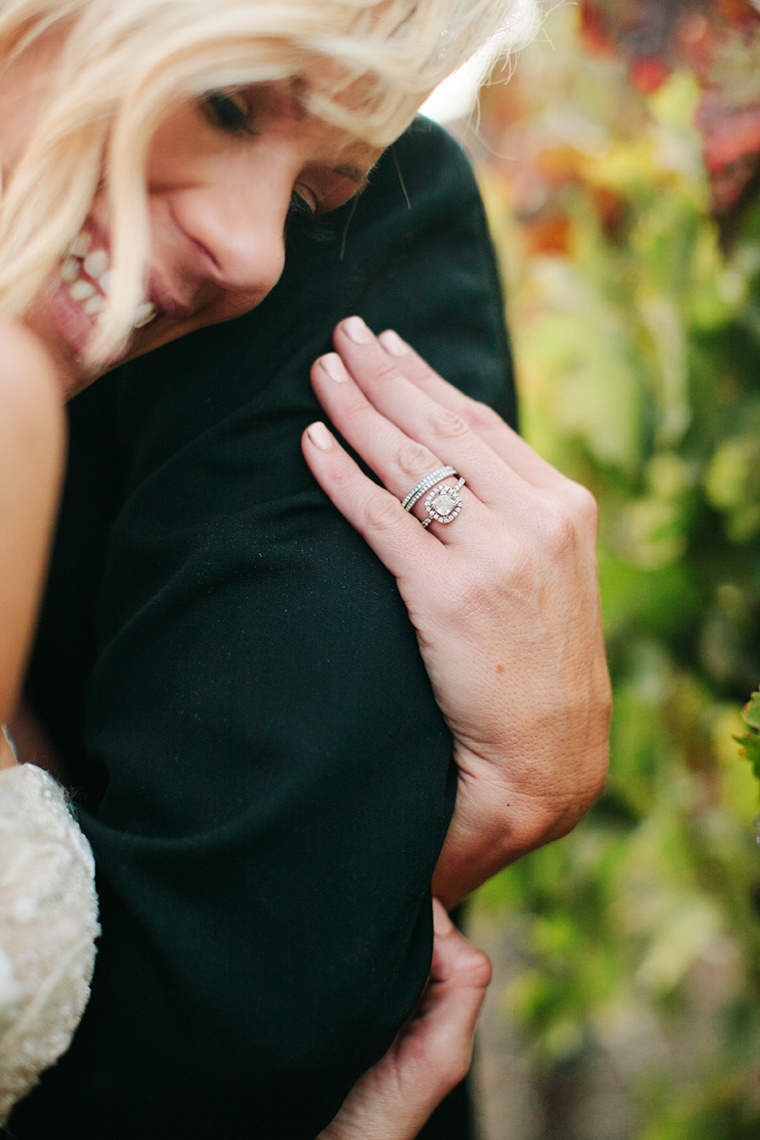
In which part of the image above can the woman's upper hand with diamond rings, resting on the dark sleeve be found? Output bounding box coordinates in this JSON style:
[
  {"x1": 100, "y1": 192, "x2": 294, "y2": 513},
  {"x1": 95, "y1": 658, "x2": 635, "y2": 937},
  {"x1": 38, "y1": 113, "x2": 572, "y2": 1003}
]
[{"x1": 304, "y1": 318, "x2": 610, "y2": 904}]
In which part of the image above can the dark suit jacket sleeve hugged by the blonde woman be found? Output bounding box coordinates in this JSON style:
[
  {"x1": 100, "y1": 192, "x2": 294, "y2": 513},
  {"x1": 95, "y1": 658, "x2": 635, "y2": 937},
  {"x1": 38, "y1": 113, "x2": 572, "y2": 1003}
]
[{"x1": 11, "y1": 122, "x2": 514, "y2": 1140}]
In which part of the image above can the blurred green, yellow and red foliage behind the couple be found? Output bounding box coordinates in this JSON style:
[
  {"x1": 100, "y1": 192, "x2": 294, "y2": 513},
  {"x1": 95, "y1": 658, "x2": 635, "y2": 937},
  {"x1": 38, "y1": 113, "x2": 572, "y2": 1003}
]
[{"x1": 432, "y1": 0, "x2": 760, "y2": 1140}]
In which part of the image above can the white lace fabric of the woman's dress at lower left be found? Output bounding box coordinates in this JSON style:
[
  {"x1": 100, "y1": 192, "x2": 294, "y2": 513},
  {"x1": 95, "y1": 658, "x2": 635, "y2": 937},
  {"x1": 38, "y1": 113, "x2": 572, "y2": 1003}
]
[{"x1": 0, "y1": 764, "x2": 99, "y2": 1123}]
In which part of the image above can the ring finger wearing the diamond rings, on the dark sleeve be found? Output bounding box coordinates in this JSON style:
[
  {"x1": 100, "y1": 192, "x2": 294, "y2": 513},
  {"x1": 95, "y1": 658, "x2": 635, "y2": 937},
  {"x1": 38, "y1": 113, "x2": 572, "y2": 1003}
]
[{"x1": 312, "y1": 352, "x2": 484, "y2": 540}]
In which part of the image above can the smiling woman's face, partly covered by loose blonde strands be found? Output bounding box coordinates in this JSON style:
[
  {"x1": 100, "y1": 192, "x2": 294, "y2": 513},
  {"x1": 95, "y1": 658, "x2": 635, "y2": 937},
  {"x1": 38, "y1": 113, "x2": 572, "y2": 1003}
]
[{"x1": 0, "y1": 34, "x2": 379, "y2": 398}]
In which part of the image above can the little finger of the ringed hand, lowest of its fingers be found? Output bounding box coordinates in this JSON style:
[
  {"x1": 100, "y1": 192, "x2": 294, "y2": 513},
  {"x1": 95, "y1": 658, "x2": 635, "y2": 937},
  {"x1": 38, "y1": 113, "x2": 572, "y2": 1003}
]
[{"x1": 302, "y1": 423, "x2": 446, "y2": 584}]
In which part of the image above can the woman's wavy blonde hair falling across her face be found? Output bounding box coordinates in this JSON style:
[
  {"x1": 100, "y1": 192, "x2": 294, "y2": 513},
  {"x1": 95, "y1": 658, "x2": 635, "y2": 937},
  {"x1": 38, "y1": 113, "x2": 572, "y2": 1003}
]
[{"x1": 0, "y1": 0, "x2": 537, "y2": 359}]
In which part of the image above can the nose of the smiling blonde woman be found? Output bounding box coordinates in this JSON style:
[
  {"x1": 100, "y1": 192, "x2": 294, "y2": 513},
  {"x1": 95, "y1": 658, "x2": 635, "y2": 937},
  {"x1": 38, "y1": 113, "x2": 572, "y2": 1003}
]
[{"x1": 180, "y1": 180, "x2": 291, "y2": 300}]
